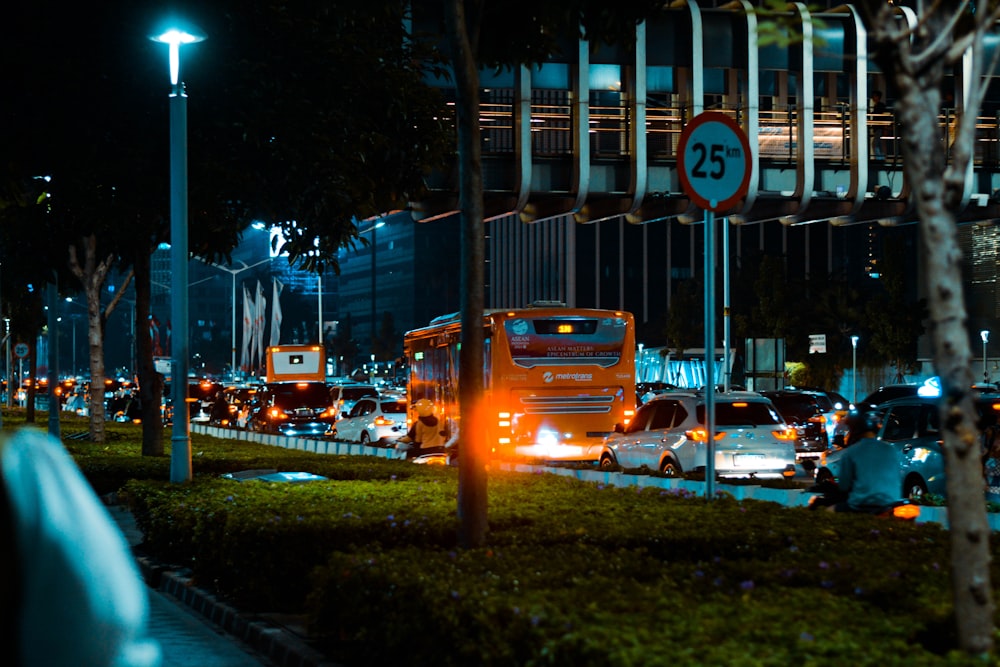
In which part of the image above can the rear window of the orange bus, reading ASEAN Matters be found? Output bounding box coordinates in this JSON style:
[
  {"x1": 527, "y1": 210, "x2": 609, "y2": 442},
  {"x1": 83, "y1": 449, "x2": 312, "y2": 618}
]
[{"x1": 503, "y1": 316, "x2": 628, "y2": 368}]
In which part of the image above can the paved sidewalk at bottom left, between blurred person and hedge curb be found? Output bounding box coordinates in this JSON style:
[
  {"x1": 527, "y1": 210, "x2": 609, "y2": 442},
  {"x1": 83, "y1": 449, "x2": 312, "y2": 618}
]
[{"x1": 108, "y1": 505, "x2": 338, "y2": 667}]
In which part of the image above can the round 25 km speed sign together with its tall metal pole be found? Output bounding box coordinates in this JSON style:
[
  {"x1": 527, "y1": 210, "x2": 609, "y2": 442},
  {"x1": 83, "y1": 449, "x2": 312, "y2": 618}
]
[{"x1": 677, "y1": 111, "x2": 752, "y2": 499}]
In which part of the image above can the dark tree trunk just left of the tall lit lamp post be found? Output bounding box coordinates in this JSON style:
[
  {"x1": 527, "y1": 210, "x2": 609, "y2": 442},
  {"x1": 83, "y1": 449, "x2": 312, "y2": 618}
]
[{"x1": 133, "y1": 250, "x2": 164, "y2": 456}]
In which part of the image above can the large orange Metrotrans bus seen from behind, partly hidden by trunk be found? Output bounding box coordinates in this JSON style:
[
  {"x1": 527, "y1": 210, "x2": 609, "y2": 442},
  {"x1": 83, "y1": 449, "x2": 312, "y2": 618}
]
[{"x1": 403, "y1": 303, "x2": 636, "y2": 461}]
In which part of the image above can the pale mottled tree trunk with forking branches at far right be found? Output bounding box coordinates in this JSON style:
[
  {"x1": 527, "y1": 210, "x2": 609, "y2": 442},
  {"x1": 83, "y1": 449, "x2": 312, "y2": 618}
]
[{"x1": 873, "y1": 5, "x2": 994, "y2": 655}]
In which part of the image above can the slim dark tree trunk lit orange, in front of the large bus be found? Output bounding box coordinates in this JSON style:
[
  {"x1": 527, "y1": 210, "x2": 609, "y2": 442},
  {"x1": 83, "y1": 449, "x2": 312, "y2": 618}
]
[{"x1": 445, "y1": 0, "x2": 489, "y2": 548}]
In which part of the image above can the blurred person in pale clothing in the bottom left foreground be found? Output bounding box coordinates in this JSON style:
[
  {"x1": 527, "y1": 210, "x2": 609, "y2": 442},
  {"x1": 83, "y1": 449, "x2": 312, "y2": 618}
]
[{"x1": 0, "y1": 429, "x2": 161, "y2": 667}]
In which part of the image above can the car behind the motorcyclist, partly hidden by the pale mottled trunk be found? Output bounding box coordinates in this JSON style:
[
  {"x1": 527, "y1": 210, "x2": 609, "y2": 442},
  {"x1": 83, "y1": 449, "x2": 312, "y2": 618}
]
[{"x1": 816, "y1": 394, "x2": 1000, "y2": 498}]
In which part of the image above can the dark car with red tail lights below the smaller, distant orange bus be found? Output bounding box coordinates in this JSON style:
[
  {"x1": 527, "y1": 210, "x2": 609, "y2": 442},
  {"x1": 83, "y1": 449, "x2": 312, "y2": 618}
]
[{"x1": 250, "y1": 382, "x2": 337, "y2": 436}]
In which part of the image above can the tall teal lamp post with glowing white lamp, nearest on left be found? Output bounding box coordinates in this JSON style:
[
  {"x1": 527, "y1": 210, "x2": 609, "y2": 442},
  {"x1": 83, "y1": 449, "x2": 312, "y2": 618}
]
[{"x1": 150, "y1": 23, "x2": 205, "y2": 482}]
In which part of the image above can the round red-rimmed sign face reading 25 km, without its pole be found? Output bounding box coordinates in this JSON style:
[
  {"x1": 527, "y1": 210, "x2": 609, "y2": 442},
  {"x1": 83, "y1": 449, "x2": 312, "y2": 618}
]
[{"x1": 677, "y1": 111, "x2": 751, "y2": 213}]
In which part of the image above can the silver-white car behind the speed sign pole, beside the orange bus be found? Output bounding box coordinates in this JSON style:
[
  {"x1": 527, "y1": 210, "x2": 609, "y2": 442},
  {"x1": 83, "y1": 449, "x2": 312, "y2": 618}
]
[{"x1": 600, "y1": 391, "x2": 795, "y2": 478}]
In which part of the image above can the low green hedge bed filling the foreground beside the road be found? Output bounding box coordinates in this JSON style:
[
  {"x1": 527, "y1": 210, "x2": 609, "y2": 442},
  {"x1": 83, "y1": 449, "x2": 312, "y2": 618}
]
[{"x1": 9, "y1": 414, "x2": 1000, "y2": 667}]
